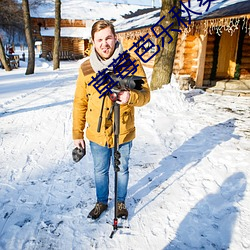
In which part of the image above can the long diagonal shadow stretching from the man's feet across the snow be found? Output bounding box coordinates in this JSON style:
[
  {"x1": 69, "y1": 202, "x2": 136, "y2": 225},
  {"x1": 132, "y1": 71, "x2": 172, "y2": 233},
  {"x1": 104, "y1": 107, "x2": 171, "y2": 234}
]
[{"x1": 128, "y1": 119, "x2": 239, "y2": 217}]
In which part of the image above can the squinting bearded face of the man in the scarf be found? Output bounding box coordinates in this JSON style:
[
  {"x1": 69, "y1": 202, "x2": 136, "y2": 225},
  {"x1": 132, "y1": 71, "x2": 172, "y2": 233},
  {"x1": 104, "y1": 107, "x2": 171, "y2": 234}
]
[{"x1": 93, "y1": 27, "x2": 117, "y2": 60}]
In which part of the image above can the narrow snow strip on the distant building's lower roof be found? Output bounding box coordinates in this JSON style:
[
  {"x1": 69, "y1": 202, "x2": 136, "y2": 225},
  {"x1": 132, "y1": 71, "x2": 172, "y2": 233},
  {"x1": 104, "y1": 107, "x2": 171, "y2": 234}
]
[{"x1": 41, "y1": 27, "x2": 91, "y2": 39}]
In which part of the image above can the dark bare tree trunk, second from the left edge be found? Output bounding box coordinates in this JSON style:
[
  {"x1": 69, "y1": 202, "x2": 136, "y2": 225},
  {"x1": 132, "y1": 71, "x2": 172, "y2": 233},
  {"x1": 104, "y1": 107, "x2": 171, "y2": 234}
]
[{"x1": 22, "y1": 0, "x2": 35, "y2": 75}]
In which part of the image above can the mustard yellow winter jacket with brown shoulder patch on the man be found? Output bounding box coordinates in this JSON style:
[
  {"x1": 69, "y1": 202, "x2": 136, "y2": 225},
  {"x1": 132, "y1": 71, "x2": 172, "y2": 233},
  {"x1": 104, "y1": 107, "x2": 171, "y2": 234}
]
[{"x1": 72, "y1": 54, "x2": 150, "y2": 148}]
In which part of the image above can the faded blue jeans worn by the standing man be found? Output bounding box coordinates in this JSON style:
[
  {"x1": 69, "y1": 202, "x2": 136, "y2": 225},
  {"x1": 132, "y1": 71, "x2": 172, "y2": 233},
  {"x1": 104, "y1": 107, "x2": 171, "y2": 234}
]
[{"x1": 90, "y1": 141, "x2": 132, "y2": 204}]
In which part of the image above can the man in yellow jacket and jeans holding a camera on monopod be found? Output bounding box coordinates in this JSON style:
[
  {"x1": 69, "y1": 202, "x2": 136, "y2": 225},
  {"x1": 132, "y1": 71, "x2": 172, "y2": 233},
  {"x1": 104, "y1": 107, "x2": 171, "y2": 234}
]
[{"x1": 73, "y1": 20, "x2": 150, "y2": 219}]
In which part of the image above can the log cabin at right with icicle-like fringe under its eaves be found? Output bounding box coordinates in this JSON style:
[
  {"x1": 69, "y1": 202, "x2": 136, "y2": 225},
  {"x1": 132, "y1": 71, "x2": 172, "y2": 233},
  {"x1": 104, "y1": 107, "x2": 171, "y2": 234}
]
[{"x1": 114, "y1": 0, "x2": 250, "y2": 94}]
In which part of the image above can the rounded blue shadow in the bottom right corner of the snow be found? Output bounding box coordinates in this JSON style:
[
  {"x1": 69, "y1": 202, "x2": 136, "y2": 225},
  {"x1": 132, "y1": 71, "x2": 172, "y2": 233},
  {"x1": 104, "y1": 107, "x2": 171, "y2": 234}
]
[{"x1": 164, "y1": 172, "x2": 247, "y2": 250}]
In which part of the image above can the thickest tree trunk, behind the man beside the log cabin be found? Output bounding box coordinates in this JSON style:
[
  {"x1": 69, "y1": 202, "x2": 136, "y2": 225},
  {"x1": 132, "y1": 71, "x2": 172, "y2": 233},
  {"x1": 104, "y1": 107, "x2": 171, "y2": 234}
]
[{"x1": 150, "y1": 0, "x2": 180, "y2": 90}]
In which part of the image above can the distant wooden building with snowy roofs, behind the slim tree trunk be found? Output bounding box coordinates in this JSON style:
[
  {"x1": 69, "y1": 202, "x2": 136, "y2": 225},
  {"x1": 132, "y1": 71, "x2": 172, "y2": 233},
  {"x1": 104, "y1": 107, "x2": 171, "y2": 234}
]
[{"x1": 31, "y1": 0, "x2": 150, "y2": 59}]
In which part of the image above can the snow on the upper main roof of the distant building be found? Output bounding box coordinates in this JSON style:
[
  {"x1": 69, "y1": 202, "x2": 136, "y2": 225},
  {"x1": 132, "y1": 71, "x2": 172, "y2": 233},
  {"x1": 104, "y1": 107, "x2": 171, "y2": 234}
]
[{"x1": 30, "y1": 0, "x2": 150, "y2": 20}]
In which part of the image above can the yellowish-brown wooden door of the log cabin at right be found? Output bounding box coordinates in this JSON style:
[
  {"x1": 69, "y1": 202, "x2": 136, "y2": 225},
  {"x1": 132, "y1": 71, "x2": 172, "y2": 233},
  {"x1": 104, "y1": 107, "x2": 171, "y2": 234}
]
[{"x1": 216, "y1": 30, "x2": 239, "y2": 79}]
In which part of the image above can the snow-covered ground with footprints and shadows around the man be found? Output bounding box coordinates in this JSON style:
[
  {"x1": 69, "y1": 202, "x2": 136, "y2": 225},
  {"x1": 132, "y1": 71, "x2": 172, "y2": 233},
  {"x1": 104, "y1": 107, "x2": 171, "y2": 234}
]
[{"x1": 0, "y1": 49, "x2": 250, "y2": 250}]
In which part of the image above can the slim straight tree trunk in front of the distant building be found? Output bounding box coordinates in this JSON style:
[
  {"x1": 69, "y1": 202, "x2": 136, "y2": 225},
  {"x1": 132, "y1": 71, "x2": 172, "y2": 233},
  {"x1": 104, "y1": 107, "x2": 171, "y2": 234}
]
[{"x1": 53, "y1": 0, "x2": 61, "y2": 70}]
